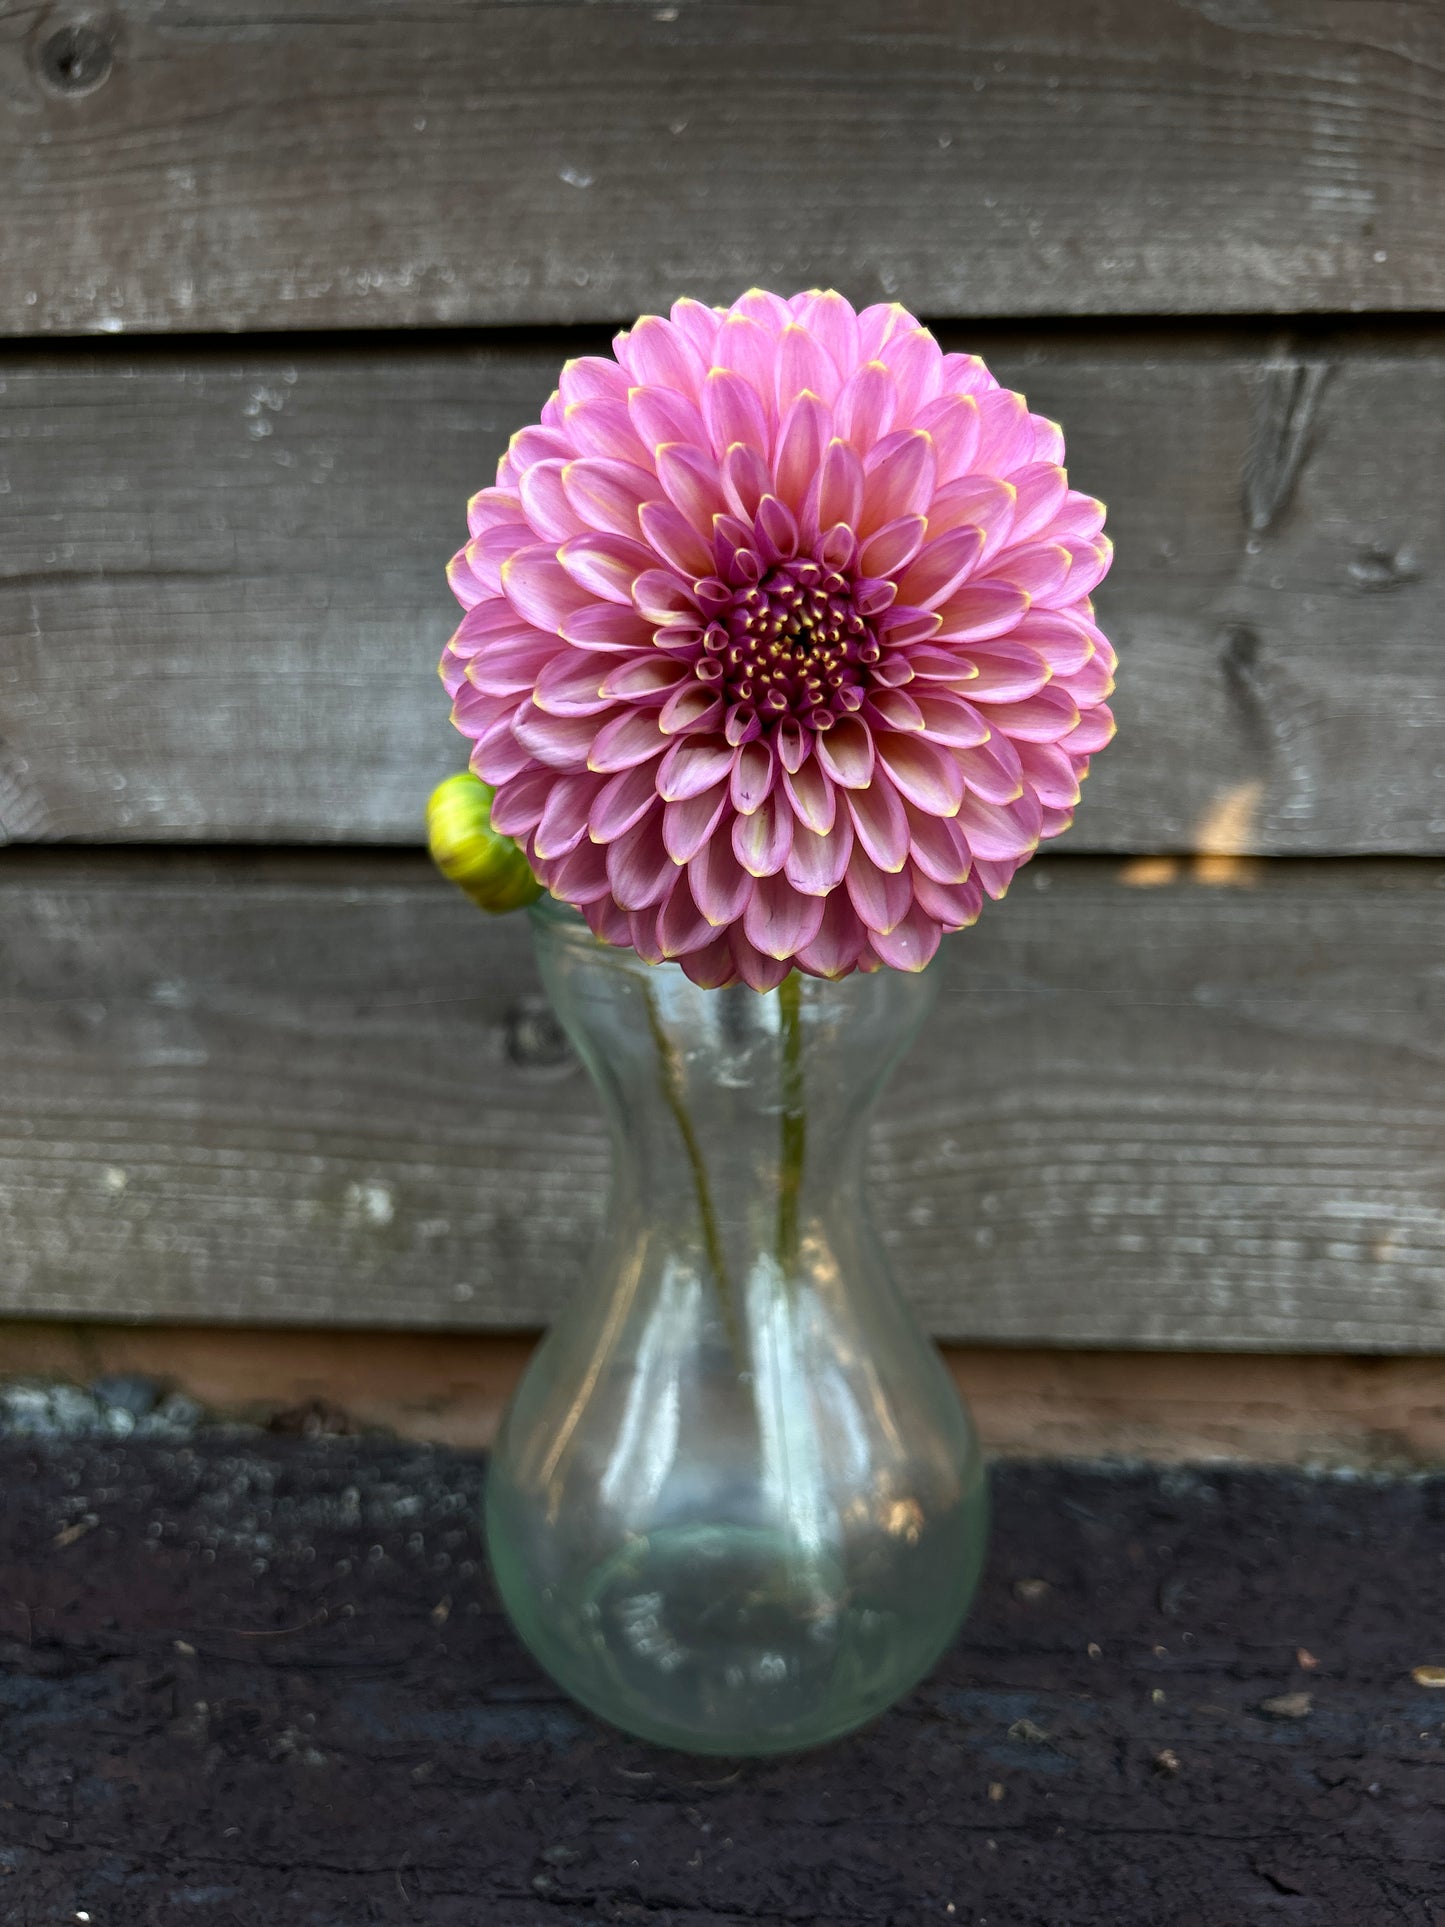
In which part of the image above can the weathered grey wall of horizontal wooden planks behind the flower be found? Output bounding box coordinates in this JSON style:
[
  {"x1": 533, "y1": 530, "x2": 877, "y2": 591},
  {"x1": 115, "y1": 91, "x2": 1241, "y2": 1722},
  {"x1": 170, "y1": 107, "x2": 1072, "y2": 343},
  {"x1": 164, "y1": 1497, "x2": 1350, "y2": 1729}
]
[{"x1": 0, "y1": 0, "x2": 1445, "y2": 1351}]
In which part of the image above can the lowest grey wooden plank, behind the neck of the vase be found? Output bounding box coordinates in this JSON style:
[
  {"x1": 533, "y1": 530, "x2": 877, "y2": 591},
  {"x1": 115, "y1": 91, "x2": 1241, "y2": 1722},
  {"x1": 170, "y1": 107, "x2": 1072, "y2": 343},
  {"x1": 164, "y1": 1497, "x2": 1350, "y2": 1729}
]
[{"x1": 0, "y1": 850, "x2": 1445, "y2": 1351}]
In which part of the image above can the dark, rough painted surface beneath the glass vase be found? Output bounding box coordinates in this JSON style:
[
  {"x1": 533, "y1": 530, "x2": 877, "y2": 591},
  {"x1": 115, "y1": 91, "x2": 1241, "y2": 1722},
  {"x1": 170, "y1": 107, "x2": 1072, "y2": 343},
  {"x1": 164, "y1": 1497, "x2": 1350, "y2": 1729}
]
[{"x1": 0, "y1": 1425, "x2": 1445, "y2": 1927}]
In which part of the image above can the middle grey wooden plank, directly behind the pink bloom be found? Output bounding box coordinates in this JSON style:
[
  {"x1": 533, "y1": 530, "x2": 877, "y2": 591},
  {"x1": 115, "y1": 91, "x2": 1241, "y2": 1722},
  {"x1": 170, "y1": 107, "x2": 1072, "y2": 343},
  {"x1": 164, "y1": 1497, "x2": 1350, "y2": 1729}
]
[{"x1": 0, "y1": 327, "x2": 1445, "y2": 854}]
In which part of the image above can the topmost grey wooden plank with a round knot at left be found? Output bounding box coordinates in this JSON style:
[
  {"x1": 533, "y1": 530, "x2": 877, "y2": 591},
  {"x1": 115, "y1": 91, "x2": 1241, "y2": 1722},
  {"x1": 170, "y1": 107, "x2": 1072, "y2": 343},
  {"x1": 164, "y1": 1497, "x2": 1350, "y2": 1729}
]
[{"x1": 0, "y1": 0, "x2": 1445, "y2": 333}]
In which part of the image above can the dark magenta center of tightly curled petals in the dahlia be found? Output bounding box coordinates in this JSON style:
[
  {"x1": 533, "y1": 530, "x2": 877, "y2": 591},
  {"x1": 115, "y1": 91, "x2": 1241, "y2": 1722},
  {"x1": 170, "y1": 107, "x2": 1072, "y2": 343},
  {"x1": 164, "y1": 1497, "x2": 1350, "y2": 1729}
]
[{"x1": 696, "y1": 559, "x2": 880, "y2": 736}]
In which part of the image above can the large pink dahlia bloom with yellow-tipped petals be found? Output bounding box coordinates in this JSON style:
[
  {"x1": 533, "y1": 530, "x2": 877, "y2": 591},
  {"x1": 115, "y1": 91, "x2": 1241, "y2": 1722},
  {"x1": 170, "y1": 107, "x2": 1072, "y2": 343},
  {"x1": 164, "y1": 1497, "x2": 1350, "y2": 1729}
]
[{"x1": 441, "y1": 291, "x2": 1114, "y2": 990}]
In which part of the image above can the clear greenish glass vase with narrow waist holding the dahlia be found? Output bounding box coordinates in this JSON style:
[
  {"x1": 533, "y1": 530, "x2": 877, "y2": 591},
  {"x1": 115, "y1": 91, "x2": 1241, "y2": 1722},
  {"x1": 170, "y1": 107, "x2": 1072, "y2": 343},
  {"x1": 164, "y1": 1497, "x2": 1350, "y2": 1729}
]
[{"x1": 487, "y1": 898, "x2": 986, "y2": 1755}]
